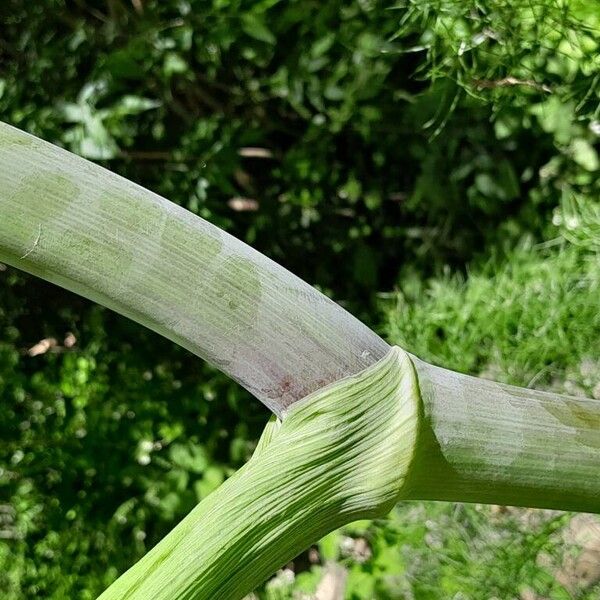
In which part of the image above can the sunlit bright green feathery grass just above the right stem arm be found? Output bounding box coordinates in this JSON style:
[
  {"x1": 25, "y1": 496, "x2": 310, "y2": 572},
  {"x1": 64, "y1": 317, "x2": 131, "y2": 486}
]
[{"x1": 388, "y1": 238, "x2": 600, "y2": 384}]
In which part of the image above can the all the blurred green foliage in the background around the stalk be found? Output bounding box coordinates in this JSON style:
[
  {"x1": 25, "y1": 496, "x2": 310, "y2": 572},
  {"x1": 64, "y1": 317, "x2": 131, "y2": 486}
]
[{"x1": 0, "y1": 0, "x2": 600, "y2": 600}]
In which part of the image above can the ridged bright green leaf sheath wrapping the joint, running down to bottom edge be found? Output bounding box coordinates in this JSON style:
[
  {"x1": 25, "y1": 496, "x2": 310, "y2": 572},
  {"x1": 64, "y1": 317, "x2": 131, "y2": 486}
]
[{"x1": 100, "y1": 348, "x2": 419, "y2": 600}]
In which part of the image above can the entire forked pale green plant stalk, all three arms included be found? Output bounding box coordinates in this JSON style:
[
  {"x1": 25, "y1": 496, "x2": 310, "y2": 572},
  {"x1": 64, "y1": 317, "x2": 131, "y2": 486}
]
[{"x1": 0, "y1": 119, "x2": 600, "y2": 600}]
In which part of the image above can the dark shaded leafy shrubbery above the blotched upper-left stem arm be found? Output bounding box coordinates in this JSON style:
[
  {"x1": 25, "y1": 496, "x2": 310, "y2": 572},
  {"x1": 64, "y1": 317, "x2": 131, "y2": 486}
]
[{"x1": 0, "y1": 0, "x2": 598, "y2": 298}]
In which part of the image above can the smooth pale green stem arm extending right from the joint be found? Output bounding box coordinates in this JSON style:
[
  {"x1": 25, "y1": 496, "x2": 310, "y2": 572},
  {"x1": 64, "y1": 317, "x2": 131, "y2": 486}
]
[{"x1": 405, "y1": 358, "x2": 600, "y2": 513}]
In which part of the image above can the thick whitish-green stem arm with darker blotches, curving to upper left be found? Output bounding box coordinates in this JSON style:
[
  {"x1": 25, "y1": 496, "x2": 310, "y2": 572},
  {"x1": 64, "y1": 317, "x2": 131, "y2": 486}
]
[{"x1": 0, "y1": 123, "x2": 389, "y2": 415}]
